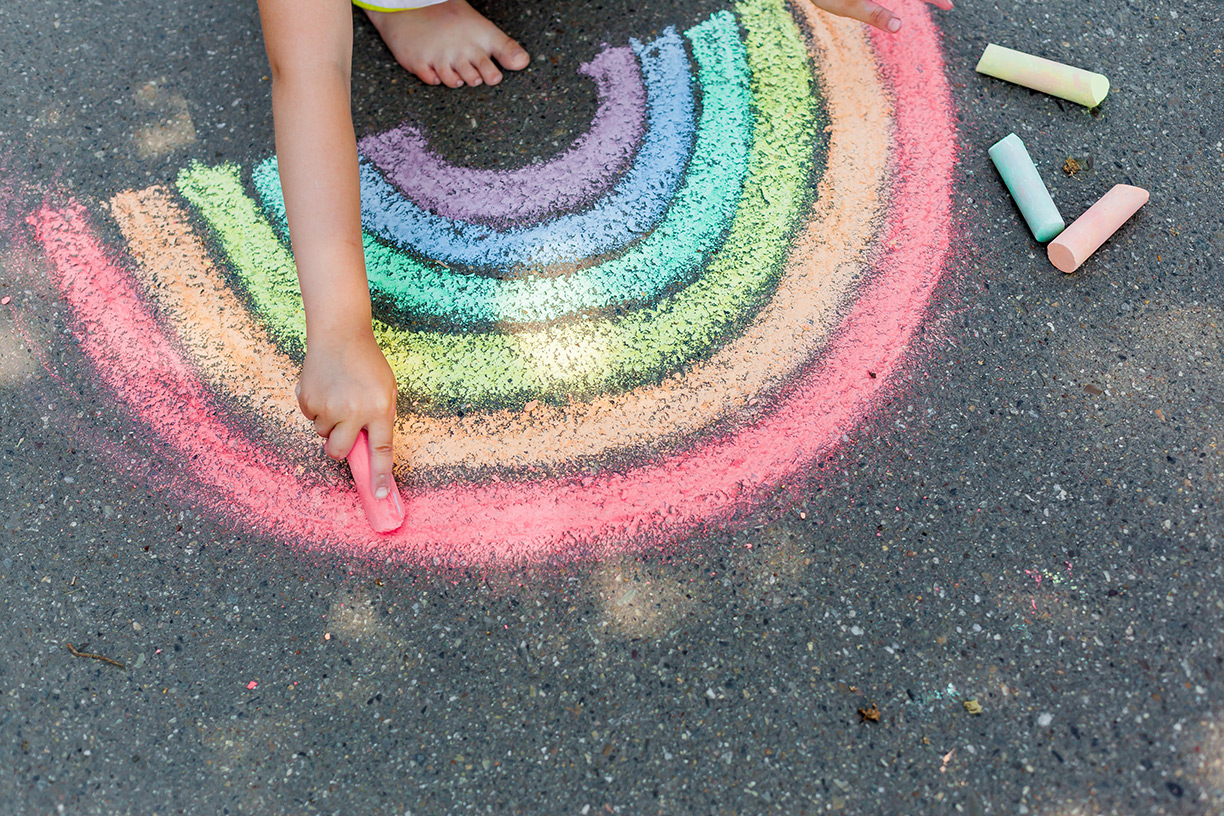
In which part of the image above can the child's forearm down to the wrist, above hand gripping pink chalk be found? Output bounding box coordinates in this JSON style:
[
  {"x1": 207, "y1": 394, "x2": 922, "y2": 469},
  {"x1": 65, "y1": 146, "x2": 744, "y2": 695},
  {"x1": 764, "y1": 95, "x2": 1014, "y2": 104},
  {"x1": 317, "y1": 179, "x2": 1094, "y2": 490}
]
[{"x1": 262, "y1": 0, "x2": 371, "y2": 346}]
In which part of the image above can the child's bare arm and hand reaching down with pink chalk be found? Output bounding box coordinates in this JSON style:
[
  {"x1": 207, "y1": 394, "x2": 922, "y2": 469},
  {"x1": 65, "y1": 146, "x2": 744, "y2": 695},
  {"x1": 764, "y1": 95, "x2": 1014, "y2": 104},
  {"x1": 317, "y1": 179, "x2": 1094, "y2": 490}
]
[{"x1": 259, "y1": 0, "x2": 395, "y2": 498}]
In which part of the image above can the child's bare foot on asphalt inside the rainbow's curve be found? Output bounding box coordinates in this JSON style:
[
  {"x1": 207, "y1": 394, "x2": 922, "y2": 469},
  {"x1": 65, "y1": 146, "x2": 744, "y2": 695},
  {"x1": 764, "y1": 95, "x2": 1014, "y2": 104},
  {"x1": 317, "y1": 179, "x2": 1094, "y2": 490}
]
[{"x1": 366, "y1": 0, "x2": 530, "y2": 88}]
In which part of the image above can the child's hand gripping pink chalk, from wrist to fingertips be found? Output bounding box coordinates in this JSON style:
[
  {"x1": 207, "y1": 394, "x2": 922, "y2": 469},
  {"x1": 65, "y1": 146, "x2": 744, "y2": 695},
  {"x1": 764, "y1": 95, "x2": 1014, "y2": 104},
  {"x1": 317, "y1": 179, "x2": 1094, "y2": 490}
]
[{"x1": 297, "y1": 330, "x2": 395, "y2": 499}]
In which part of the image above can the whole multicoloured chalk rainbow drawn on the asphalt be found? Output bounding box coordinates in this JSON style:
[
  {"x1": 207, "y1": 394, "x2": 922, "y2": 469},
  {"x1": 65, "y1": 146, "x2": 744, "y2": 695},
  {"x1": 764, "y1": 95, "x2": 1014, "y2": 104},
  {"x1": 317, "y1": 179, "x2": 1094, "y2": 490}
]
[{"x1": 28, "y1": 0, "x2": 956, "y2": 565}]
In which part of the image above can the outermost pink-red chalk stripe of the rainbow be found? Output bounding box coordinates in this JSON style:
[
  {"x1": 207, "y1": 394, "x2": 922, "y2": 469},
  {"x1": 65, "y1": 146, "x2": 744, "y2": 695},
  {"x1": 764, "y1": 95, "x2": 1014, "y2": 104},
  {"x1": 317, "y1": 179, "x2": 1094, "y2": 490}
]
[{"x1": 29, "y1": 0, "x2": 956, "y2": 566}]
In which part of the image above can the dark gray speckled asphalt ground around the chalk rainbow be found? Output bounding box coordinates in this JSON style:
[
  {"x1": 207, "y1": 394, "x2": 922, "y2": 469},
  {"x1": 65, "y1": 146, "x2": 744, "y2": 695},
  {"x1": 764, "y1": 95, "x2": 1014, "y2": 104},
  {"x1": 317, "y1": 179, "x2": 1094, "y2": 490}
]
[{"x1": 0, "y1": 0, "x2": 1224, "y2": 816}]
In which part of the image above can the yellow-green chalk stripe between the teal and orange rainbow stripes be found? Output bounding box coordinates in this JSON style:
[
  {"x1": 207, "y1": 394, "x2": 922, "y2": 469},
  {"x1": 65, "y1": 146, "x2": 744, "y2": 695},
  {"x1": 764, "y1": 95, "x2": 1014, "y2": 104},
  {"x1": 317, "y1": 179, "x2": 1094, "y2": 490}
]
[{"x1": 179, "y1": 0, "x2": 820, "y2": 412}]
